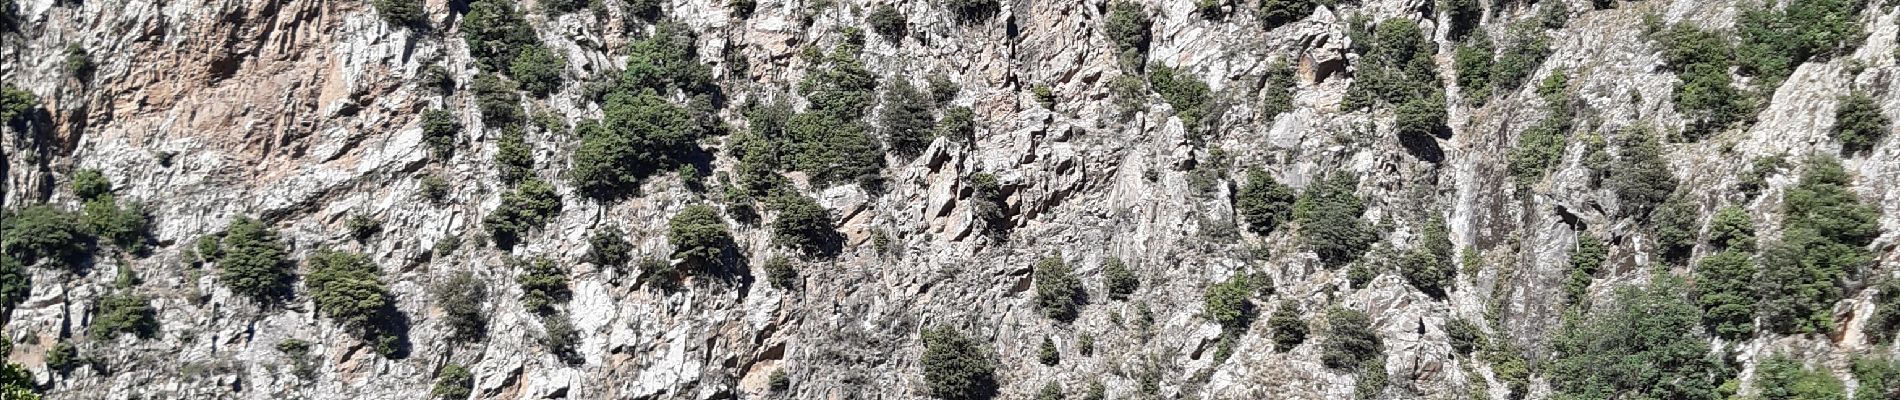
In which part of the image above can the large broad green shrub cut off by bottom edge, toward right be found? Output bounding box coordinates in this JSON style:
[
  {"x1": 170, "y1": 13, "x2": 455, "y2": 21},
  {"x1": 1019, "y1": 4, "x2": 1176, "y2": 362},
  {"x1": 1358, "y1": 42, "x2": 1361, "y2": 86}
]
[{"x1": 1547, "y1": 275, "x2": 1731, "y2": 400}]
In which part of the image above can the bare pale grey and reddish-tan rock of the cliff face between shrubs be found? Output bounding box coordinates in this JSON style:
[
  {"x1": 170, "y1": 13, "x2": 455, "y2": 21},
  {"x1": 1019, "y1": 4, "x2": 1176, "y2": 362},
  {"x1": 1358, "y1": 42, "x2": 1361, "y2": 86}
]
[{"x1": 11, "y1": 0, "x2": 1900, "y2": 398}]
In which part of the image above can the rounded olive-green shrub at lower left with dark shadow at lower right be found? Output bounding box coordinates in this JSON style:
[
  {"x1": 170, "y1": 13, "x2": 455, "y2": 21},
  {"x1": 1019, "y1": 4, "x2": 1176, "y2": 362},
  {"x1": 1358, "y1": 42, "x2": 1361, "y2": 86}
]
[{"x1": 306, "y1": 248, "x2": 395, "y2": 328}]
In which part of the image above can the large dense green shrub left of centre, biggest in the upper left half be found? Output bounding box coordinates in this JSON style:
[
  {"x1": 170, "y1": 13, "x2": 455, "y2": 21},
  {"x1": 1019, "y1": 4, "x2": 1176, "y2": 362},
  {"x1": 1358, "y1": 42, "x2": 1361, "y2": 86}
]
[{"x1": 568, "y1": 91, "x2": 705, "y2": 199}]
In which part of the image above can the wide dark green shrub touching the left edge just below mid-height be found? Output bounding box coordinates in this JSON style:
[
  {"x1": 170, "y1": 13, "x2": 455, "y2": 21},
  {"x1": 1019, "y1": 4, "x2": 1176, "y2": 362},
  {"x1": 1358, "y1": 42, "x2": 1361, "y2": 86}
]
[{"x1": 0, "y1": 205, "x2": 95, "y2": 267}]
